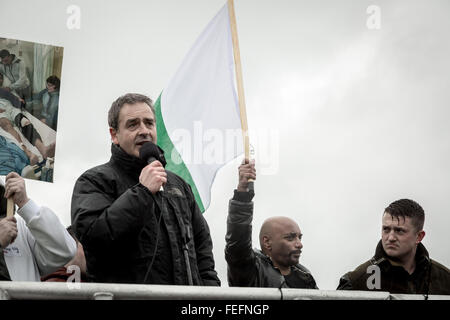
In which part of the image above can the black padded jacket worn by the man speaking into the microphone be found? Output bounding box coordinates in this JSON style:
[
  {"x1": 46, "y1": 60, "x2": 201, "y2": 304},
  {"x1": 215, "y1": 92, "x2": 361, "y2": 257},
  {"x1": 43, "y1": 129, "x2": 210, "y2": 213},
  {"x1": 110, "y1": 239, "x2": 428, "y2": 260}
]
[{"x1": 72, "y1": 144, "x2": 220, "y2": 286}]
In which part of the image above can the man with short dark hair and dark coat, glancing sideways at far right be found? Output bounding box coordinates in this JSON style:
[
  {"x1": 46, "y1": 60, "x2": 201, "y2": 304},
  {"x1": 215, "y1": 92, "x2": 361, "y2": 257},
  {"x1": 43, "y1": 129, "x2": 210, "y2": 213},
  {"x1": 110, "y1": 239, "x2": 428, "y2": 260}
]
[{"x1": 338, "y1": 199, "x2": 450, "y2": 295}]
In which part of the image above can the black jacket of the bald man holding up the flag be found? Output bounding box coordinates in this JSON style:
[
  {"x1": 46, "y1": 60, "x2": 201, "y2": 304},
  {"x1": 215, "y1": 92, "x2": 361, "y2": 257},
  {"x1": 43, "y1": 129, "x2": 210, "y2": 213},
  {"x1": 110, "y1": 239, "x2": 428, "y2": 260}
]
[{"x1": 225, "y1": 190, "x2": 317, "y2": 289}]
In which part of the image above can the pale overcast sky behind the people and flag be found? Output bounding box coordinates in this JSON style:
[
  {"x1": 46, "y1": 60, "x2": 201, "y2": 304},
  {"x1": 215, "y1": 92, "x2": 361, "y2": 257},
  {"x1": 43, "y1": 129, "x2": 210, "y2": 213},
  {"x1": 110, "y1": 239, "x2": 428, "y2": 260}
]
[{"x1": 0, "y1": 0, "x2": 450, "y2": 289}]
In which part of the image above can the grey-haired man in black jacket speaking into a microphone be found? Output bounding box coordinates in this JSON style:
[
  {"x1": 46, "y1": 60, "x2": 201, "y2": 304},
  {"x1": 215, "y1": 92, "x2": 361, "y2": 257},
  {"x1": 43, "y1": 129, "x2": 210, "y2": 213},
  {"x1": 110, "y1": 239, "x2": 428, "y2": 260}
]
[{"x1": 72, "y1": 93, "x2": 220, "y2": 286}]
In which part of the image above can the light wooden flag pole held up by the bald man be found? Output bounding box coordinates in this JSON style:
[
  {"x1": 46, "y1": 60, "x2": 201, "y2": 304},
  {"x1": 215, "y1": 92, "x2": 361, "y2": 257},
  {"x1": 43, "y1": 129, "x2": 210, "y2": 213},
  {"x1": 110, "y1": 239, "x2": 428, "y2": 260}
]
[{"x1": 228, "y1": 0, "x2": 250, "y2": 159}]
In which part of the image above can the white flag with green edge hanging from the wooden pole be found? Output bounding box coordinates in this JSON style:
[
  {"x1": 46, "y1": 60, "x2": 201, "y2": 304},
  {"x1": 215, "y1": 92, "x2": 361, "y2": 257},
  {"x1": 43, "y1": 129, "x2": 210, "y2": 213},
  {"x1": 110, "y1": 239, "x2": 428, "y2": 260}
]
[{"x1": 155, "y1": 5, "x2": 243, "y2": 212}]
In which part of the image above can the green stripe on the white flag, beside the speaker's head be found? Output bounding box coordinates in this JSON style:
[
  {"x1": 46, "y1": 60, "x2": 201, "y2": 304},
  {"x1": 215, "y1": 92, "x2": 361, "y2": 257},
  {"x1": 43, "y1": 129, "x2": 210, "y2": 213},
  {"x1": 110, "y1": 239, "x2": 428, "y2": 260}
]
[{"x1": 155, "y1": 95, "x2": 205, "y2": 212}]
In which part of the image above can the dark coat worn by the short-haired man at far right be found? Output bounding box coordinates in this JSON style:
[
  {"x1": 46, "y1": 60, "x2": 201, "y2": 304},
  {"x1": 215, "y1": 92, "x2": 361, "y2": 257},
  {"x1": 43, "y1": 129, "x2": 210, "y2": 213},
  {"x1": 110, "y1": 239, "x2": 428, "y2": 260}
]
[{"x1": 337, "y1": 240, "x2": 450, "y2": 294}]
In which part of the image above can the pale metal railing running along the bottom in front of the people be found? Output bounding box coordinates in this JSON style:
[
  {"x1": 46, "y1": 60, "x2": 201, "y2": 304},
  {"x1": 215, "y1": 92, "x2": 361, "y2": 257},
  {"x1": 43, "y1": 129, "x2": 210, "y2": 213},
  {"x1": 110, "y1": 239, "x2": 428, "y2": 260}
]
[{"x1": 0, "y1": 281, "x2": 450, "y2": 300}]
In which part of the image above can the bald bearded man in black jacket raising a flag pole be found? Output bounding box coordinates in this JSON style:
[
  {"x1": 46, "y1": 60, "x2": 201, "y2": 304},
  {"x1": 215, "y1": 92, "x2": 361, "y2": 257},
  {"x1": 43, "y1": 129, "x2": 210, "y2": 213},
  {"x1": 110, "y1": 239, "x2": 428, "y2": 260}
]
[{"x1": 225, "y1": 159, "x2": 318, "y2": 289}]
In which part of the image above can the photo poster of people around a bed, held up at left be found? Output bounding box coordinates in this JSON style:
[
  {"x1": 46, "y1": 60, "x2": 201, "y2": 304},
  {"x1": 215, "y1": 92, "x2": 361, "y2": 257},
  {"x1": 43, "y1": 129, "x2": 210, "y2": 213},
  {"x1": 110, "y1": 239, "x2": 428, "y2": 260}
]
[{"x1": 0, "y1": 35, "x2": 64, "y2": 182}]
